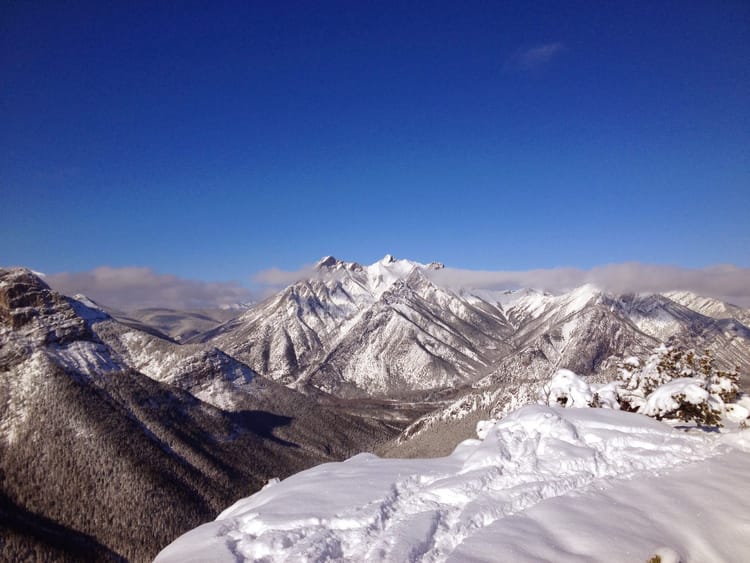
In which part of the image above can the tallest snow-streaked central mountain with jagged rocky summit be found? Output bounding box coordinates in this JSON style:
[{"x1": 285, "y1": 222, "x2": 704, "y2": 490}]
[{"x1": 201, "y1": 255, "x2": 510, "y2": 396}]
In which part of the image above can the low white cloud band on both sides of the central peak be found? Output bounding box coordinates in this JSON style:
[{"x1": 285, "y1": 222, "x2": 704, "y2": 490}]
[{"x1": 45, "y1": 262, "x2": 750, "y2": 310}]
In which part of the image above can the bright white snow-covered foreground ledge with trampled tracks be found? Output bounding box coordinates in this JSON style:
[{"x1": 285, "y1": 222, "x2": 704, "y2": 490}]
[{"x1": 157, "y1": 406, "x2": 750, "y2": 562}]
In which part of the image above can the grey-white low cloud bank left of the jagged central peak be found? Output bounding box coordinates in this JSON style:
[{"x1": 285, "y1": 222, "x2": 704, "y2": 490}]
[{"x1": 45, "y1": 266, "x2": 252, "y2": 310}]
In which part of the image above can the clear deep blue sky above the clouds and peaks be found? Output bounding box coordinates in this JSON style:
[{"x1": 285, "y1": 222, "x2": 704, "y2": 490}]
[{"x1": 0, "y1": 1, "x2": 750, "y2": 280}]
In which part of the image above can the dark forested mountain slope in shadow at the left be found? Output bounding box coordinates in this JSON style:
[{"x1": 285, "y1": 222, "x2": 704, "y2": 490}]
[{"x1": 0, "y1": 269, "x2": 406, "y2": 561}]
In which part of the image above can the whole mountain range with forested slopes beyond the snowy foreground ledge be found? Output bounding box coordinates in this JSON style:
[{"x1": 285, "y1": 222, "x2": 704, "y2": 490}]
[{"x1": 0, "y1": 256, "x2": 750, "y2": 560}]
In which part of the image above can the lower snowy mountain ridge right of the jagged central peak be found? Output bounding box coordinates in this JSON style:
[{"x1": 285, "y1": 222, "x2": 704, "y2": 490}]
[{"x1": 381, "y1": 286, "x2": 750, "y2": 456}]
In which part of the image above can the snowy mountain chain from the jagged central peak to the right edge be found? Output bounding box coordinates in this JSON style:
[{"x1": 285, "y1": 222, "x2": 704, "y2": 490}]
[{"x1": 200, "y1": 255, "x2": 750, "y2": 397}]
